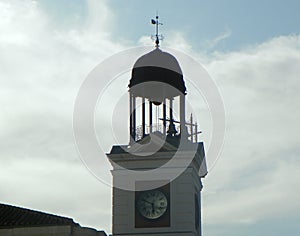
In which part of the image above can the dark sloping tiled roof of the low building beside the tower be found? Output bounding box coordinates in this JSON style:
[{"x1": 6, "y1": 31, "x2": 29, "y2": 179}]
[{"x1": 0, "y1": 204, "x2": 79, "y2": 228}]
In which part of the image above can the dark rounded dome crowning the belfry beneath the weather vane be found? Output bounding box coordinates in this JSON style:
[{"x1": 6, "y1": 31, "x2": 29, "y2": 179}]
[{"x1": 129, "y1": 48, "x2": 186, "y2": 99}]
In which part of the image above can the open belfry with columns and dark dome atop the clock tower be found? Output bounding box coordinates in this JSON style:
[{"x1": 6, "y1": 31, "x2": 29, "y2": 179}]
[{"x1": 129, "y1": 48, "x2": 186, "y2": 143}]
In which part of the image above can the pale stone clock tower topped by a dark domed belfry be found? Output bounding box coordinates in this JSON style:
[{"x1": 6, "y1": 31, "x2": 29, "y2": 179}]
[{"x1": 107, "y1": 25, "x2": 207, "y2": 236}]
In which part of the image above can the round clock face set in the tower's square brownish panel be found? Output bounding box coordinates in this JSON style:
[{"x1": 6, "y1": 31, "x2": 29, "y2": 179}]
[{"x1": 137, "y1": 190, "x2": 168, "y2": 220}]
